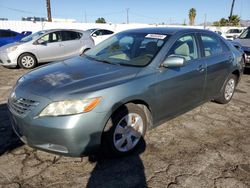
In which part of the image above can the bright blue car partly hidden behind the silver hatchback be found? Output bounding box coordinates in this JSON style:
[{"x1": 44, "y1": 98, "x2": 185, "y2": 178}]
[{"x1": 0, "y1": 29, "x2": 32, "y2": 47}]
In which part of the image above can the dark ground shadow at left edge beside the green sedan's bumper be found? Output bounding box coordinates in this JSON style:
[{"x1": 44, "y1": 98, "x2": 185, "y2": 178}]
[{"x1": 0, "y1": 104, "x2": 23, "y2": 155}]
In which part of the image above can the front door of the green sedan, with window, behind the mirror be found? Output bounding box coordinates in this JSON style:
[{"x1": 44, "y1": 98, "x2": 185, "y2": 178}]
[{"x1": 155, "y1": 34, "x2": 206, "y2": 120}]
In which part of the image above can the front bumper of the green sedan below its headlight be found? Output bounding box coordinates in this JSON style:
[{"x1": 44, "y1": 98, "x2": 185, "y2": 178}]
[{"x1": 8, "y1": 94, "x2": 107, "y2": 157}]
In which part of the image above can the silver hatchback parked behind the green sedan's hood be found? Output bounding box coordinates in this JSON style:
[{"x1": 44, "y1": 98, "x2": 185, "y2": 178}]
[{"x1": 0, "y1": 29, "x2": 94, "y2": 69}]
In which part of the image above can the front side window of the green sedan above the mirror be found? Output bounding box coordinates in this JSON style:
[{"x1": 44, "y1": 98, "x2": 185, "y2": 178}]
[{"x1": 167, "y1": 35, "x2": 198, "y2": 61}]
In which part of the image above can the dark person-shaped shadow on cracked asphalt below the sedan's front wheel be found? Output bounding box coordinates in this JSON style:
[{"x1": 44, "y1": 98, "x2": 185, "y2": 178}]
[{"x1": 86, "y1": 105, "x2": 147, "y2": 188}]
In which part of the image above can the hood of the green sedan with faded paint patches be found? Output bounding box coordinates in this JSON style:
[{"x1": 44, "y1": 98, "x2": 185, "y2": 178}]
[{"x1": 16, "y1": 56, "x2": 141, "y2": 99}]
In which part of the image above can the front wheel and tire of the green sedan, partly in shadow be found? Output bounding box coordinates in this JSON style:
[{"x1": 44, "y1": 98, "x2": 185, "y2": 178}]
[{"x1": 102, "y1": 103, "x2": 147, "y2": 157}]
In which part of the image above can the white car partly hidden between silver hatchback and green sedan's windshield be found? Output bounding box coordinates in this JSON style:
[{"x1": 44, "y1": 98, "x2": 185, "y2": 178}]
[{"x1": 87, "y1": 28, "x2": 114, "y2": 45}]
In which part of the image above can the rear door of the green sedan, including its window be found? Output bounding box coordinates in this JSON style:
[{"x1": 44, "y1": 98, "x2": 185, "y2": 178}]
[{"x1": 200, "y1": 34, "x2": 233, "y2": 98}]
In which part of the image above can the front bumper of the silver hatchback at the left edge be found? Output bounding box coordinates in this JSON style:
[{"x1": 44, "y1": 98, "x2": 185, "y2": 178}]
[{"x1": 0, "y1": 52, "x2": 18, "y2": 67}]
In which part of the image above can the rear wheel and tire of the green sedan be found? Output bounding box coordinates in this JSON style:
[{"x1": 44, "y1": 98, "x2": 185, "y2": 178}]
[{"x1": 215, "y1": 74, "x2": 238, "y2": 104}]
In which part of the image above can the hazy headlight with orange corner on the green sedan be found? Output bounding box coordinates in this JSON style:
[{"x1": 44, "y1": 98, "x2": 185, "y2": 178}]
[{"x1": 39, "y1": 97, "x2": 101, "y2": 117}]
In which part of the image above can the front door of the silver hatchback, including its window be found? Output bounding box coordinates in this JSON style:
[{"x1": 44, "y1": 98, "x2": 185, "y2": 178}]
[{"x1": 36, "y1": 31, "x2": 64, "y2": 62}]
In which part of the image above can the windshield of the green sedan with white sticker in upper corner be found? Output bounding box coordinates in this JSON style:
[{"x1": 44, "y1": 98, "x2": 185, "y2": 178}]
[{"x1": 85, "y1": 32, "x2": 170, "y2": 66}]
